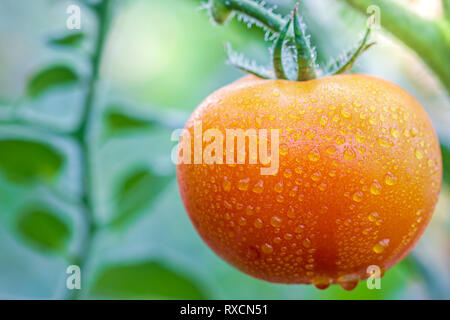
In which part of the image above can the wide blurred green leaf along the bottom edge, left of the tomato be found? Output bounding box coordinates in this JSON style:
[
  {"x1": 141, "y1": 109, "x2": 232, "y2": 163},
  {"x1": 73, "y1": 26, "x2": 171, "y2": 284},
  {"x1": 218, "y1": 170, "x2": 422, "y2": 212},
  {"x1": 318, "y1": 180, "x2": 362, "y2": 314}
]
[{"x1": 91, "y1": 261, "x2": 206, "y2": 299}]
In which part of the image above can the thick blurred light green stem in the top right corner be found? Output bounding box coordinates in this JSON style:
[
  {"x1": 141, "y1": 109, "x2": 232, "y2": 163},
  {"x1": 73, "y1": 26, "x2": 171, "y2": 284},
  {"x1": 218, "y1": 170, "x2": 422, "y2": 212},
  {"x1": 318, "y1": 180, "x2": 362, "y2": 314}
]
[{"x1": 345, "y1": 0, "x2": 450, "y2": 91}]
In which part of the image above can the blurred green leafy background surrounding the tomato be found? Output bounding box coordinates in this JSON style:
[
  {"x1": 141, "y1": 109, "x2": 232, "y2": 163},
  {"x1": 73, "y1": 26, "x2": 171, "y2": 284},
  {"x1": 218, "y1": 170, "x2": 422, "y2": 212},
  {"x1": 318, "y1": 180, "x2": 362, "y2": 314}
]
[{"x1": 0, "y1": 0, "x2": 450, "y2": 299}]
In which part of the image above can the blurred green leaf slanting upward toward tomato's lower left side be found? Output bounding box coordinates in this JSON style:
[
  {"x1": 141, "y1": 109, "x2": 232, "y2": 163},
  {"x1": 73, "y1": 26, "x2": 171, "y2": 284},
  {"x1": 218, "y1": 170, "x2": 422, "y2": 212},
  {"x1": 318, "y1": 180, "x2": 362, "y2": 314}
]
[{"x1": 111, "y1": 169, "x2": 172, "y2": 228}]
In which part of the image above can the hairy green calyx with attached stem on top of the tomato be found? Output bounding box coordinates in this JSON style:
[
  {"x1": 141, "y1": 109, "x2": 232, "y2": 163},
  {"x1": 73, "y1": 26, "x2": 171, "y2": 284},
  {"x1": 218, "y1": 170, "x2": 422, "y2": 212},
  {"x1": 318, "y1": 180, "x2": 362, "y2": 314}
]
[{"x1": 208, "y1": 0, "x2": 374, "y2": 81}]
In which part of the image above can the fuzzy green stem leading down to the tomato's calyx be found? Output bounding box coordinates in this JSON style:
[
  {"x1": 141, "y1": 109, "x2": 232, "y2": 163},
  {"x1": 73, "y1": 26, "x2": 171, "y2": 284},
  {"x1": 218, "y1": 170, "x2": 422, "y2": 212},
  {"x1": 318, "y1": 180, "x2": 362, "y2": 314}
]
[{"x1": 212, "y1": 0, "x2": 286, "y2": 33}]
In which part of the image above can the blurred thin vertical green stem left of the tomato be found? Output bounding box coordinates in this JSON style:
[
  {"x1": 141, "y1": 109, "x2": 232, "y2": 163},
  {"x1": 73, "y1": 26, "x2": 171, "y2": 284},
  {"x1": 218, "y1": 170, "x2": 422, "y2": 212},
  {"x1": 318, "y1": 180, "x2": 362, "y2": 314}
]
[{"x1": 71, "y1": 0, "x2": 112, "y2": 299}]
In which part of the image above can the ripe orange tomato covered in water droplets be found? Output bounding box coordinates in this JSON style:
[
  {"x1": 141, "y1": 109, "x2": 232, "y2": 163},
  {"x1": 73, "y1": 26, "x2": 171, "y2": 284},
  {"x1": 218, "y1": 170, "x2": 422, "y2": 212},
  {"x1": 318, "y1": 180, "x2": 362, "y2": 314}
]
[{"x1": 177, "y1": 75, "x2": 442, "y2": 290}]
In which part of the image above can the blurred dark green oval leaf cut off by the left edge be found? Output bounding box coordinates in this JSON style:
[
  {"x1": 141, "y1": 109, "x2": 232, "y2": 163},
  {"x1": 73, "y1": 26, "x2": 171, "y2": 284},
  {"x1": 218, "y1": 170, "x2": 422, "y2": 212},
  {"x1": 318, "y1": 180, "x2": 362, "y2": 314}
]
[{"x1": 0, "y1": 139, "x2": 64, "y2": 183}]
